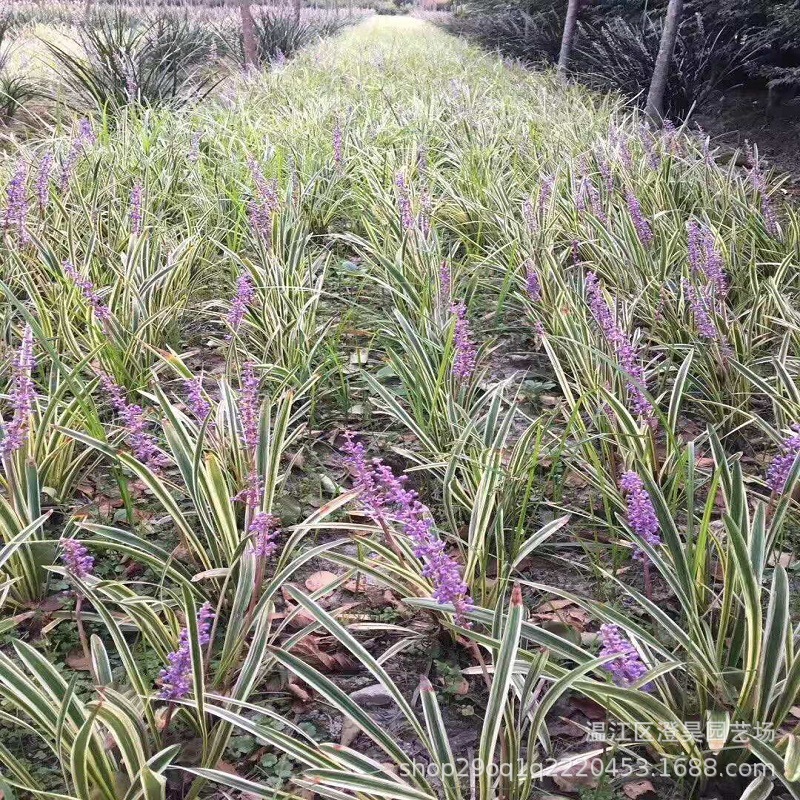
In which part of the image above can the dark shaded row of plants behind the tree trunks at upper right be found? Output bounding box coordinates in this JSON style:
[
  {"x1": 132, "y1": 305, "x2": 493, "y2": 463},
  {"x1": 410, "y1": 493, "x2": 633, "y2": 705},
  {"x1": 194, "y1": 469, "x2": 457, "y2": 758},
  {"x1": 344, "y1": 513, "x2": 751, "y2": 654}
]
[{"x1": 445, "y1": 0, "x2": 800, "y2": 120}]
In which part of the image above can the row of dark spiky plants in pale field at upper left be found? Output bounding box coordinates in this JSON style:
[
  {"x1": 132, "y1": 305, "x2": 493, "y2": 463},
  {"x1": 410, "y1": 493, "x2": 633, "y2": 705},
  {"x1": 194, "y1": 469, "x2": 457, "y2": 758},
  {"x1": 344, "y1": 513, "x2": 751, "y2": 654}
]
[{"x1": 0, "y1": 5, "x2": 360, "y2": 126}]
